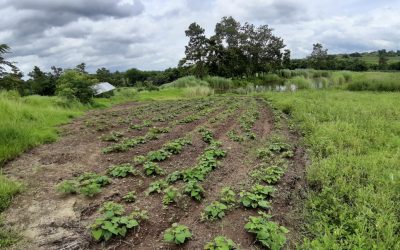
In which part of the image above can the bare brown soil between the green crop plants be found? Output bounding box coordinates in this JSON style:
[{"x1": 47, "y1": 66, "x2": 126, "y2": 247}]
[{"x1": 4, "y1": 97, "x2": 306, "y2": 249}]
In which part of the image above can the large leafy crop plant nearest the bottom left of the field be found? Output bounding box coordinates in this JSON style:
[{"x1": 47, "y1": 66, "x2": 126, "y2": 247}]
[{"x1": 91, "y1": 201, "x2": 145, "y2": 241}]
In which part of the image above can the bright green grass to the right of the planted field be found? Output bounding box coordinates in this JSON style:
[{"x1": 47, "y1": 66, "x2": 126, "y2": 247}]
[{"x1": 265, "y1": 90, "x2": 400, "y2": 249}]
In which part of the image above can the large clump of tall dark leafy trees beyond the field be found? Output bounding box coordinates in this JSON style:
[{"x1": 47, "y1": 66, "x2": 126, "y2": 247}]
[{"x1": 180, "y1": 17, "x2": 285, "y2": 77}]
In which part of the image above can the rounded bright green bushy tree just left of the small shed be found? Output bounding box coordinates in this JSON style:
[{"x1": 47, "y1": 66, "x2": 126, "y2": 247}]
[{"x1": 57, "y1": 70, "x2": 94, "y2": 103}]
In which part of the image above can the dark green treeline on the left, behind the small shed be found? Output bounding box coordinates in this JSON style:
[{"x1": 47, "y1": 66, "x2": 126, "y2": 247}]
[{"x1": 0, "y1": 44, "x2": 188, "y2": 102}]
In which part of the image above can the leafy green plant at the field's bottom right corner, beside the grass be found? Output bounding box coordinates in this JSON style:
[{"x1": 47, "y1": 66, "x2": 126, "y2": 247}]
[{"x1": 244, "y1": 212, "x2": 289, "y2": 250}]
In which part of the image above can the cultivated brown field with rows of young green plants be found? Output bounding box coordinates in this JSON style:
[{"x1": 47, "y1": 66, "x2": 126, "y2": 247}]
[{"x1": 4, "y1": 96, "x2": 306, "y2": 249}]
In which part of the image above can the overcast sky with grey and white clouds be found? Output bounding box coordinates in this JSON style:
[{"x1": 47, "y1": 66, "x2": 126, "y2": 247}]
[{"x1": 0, "y1": 0, "x2": 400, "y2": 74}]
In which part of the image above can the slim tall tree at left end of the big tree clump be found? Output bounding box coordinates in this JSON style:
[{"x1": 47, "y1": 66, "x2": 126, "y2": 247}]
[{"x1": 179, "y1": 23, "x2": 208, "y2": 77}]
